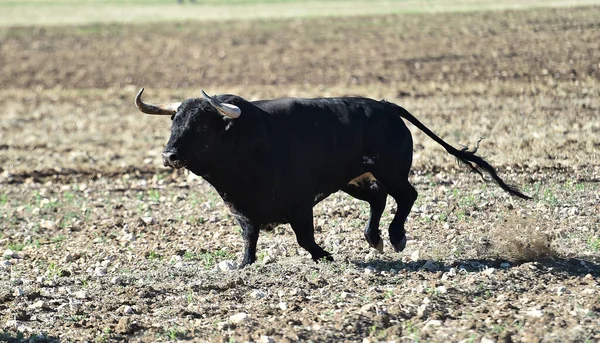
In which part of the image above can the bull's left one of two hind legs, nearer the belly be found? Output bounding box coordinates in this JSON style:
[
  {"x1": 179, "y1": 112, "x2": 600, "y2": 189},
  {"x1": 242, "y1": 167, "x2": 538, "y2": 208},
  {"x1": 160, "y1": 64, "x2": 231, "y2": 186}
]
[{"x1": 342, "y1": 174, "x2": 387, "y2": 252}]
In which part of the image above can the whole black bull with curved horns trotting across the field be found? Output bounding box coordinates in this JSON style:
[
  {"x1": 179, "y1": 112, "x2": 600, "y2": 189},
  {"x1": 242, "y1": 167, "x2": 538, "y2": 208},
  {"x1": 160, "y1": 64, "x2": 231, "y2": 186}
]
[{"x1": 136, "y1": 89, "x2": 528, "y2": 267}]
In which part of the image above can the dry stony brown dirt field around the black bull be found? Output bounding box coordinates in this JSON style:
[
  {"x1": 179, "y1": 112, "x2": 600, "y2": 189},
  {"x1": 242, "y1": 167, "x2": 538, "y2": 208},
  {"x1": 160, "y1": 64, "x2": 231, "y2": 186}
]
[{"x1": 0, "y1": 7, "x2": 600, "y2": 343}]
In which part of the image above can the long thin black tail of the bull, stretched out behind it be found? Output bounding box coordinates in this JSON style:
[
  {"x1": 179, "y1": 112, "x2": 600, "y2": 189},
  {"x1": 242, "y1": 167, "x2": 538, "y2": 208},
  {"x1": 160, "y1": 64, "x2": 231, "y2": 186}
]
[{"x1": 396, "y1": 105, "x2": 531, "y2": 199}]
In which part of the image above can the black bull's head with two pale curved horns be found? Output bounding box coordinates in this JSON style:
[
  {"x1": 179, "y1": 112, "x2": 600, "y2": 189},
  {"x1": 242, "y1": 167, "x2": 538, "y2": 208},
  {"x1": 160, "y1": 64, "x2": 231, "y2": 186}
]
[{"x1": 135, "y1": 88, "x2": 242, "y2": 168}]
